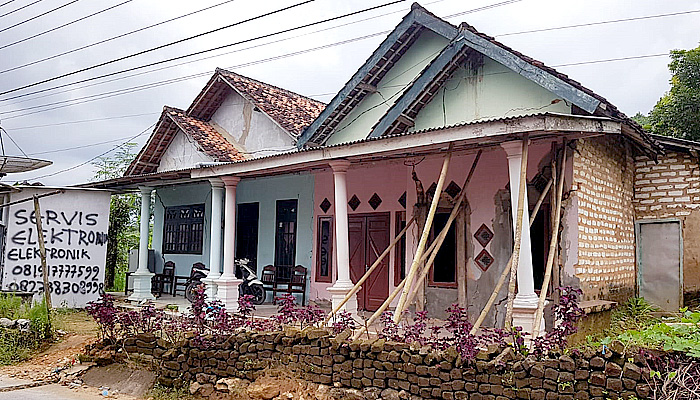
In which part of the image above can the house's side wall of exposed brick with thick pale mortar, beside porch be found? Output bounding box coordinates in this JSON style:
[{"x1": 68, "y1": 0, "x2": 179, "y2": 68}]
[{"x1": 572, "y1": 136, "x2": 635, "y2": 301}]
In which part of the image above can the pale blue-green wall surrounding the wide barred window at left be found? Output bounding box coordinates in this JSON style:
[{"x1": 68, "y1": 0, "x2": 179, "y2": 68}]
[{"x1": 151, "y1": 182, "x2": 216, "y2": 275}]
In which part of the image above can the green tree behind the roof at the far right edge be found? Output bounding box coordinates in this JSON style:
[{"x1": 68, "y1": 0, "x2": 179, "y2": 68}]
[{"x1": 649, "y1": 46, "x2": 700, "y2": 140}]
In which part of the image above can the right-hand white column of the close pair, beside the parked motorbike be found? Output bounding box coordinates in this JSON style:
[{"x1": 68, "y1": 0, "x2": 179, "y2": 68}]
[{"x1": 216, "y1": 176, "x2": 243, "y2": 311}]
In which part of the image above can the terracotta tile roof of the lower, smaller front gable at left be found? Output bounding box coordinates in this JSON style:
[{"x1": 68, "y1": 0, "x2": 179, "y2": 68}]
[{"x1": 124, "y1": 106, "x2": 245, "y2": 176}]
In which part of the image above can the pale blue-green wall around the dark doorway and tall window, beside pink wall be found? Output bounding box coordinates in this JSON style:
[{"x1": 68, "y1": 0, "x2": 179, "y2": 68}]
[{"x1": 236, "y1": 174, "x2": 314, "y2": 274}]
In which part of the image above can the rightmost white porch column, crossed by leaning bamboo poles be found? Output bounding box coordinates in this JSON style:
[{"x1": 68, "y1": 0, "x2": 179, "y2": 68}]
[{"x1": 501, "y1": 140, "x2": 544, "y2": 332}]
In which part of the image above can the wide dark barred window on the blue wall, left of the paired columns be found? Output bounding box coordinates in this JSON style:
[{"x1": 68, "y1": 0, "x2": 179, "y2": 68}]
[{"x1": 163, "y1": 204, "x2": 204, "y2": 254}]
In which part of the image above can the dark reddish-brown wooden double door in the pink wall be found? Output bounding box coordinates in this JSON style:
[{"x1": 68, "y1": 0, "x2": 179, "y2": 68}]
[{"x1": 348, "y1": 213, "x2": 390, "y2": 311}]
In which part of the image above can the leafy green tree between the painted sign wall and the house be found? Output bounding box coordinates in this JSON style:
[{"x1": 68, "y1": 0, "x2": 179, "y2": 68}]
[{"x1": 93, "y1": 143, "x2": 140, "y2": 290}]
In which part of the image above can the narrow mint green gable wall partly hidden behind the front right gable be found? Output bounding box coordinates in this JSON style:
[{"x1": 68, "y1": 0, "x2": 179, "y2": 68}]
[{"x1": 328, "y1": 30, "x2": 448, "y2": 144}]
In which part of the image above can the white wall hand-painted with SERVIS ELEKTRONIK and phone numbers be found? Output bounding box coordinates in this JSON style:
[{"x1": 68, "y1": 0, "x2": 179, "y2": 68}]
[{"x1": 2, "y1": 187, "x2": 110, "y2": 307}]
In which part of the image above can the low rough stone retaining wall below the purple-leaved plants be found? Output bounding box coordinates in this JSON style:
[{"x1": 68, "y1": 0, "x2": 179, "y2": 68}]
[{"x1": 124, "y1": 328, "x2": 650, "y2": 400}]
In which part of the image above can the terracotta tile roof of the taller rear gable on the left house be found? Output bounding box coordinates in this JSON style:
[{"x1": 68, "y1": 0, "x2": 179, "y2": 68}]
[{"x1": 187, "y1": 68, "x2": 326, "y2": 137}]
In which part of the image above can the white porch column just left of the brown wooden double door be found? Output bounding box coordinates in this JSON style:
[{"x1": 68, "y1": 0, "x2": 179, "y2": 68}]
[{"x1": 328, "y1": 160, "x2": 357, "y2": 314}]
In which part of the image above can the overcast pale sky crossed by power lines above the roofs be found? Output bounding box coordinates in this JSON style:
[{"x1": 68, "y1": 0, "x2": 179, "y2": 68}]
[{"x1": 0, "y1": 0, "x2": 700, "y2": 185}]
